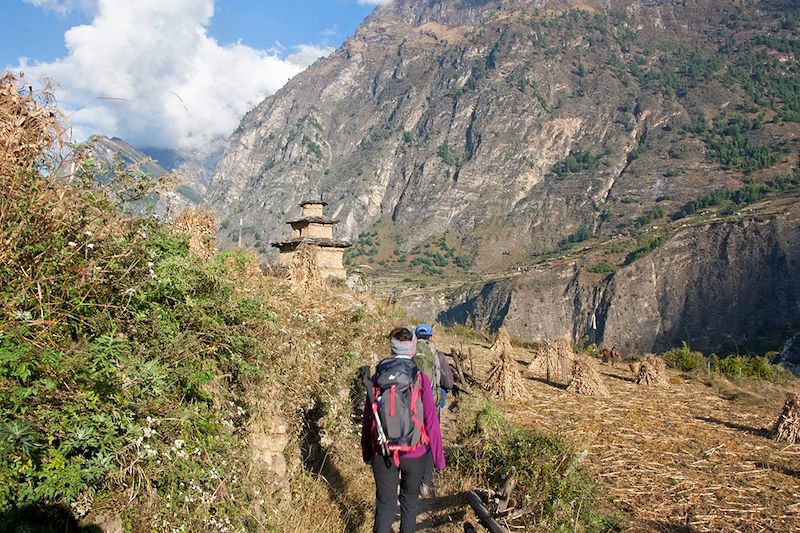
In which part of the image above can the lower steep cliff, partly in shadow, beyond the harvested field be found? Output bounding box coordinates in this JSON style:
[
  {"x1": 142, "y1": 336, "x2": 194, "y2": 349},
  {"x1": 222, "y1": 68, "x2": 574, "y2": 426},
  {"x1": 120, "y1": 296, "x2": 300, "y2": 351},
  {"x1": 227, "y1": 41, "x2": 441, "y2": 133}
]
[{"x1": 428, "y1": 197, "x2": 800, "y2": 353}]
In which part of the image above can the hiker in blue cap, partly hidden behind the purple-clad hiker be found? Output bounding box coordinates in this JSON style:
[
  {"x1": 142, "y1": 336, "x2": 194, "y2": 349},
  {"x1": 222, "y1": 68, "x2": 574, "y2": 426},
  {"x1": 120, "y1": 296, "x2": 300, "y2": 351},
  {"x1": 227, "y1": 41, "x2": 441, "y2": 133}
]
[{"x1": 414, "y1": 324, "x2": 453, "y2": 498}]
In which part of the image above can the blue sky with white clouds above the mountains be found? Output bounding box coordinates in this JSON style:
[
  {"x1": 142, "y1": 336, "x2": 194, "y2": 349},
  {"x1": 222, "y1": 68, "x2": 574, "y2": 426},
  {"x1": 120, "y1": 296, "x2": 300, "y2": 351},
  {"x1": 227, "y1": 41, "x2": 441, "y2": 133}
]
[{"x1": 0, "y1": 0, "x2": 390, "y2": 148}]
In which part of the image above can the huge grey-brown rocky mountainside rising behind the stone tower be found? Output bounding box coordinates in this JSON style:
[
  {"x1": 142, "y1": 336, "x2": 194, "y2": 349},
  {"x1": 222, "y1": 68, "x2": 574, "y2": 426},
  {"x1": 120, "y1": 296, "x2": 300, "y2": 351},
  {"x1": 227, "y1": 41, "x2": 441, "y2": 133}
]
[{"x1": 207, "y1": 0, "x2": 797, "y2": 266}]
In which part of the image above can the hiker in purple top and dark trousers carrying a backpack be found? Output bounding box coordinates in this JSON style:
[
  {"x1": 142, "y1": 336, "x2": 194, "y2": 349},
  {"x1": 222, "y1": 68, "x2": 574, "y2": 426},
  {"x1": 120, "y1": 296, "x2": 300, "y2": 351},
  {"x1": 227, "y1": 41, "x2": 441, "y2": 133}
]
[{"x1": 361, "y1": 327, "x2": 445, "y2": 533}]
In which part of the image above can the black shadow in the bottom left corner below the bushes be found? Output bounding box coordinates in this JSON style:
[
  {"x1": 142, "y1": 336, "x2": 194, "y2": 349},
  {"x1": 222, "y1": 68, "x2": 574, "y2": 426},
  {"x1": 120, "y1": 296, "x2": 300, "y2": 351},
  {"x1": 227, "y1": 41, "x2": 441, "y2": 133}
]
[{"x1": 0, "y1": 505, "x2": 103, "y2": 533}]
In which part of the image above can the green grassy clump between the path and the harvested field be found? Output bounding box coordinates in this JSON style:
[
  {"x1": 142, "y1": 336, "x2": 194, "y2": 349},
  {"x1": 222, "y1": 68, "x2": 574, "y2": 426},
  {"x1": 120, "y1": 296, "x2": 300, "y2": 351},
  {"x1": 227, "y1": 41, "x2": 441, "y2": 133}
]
[{"x1": 452, "y1": 396, "x2": 626, "y2": 531}]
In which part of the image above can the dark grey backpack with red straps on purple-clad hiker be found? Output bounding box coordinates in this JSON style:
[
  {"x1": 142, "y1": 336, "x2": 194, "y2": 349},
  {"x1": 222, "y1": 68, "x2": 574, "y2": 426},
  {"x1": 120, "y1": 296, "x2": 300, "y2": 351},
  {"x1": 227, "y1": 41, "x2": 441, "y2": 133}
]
[{"x1": 373, "y1": 357, "x2": 428, "y2": 467}]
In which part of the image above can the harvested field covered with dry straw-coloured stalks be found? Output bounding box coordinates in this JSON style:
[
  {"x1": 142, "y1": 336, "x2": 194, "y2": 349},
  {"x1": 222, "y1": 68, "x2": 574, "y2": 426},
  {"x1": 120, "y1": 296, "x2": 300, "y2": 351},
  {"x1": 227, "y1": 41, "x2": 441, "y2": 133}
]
[{"x1": 446, "y1": 338, "x2": 800, "y2": 531}]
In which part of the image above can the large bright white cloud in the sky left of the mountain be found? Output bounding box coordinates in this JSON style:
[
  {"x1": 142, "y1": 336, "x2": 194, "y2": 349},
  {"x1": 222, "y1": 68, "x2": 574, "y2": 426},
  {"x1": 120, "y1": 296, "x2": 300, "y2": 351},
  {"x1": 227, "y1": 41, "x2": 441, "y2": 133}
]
[{"x1": 19, "y1": 0, "x2": 331, "y2": 148}]
